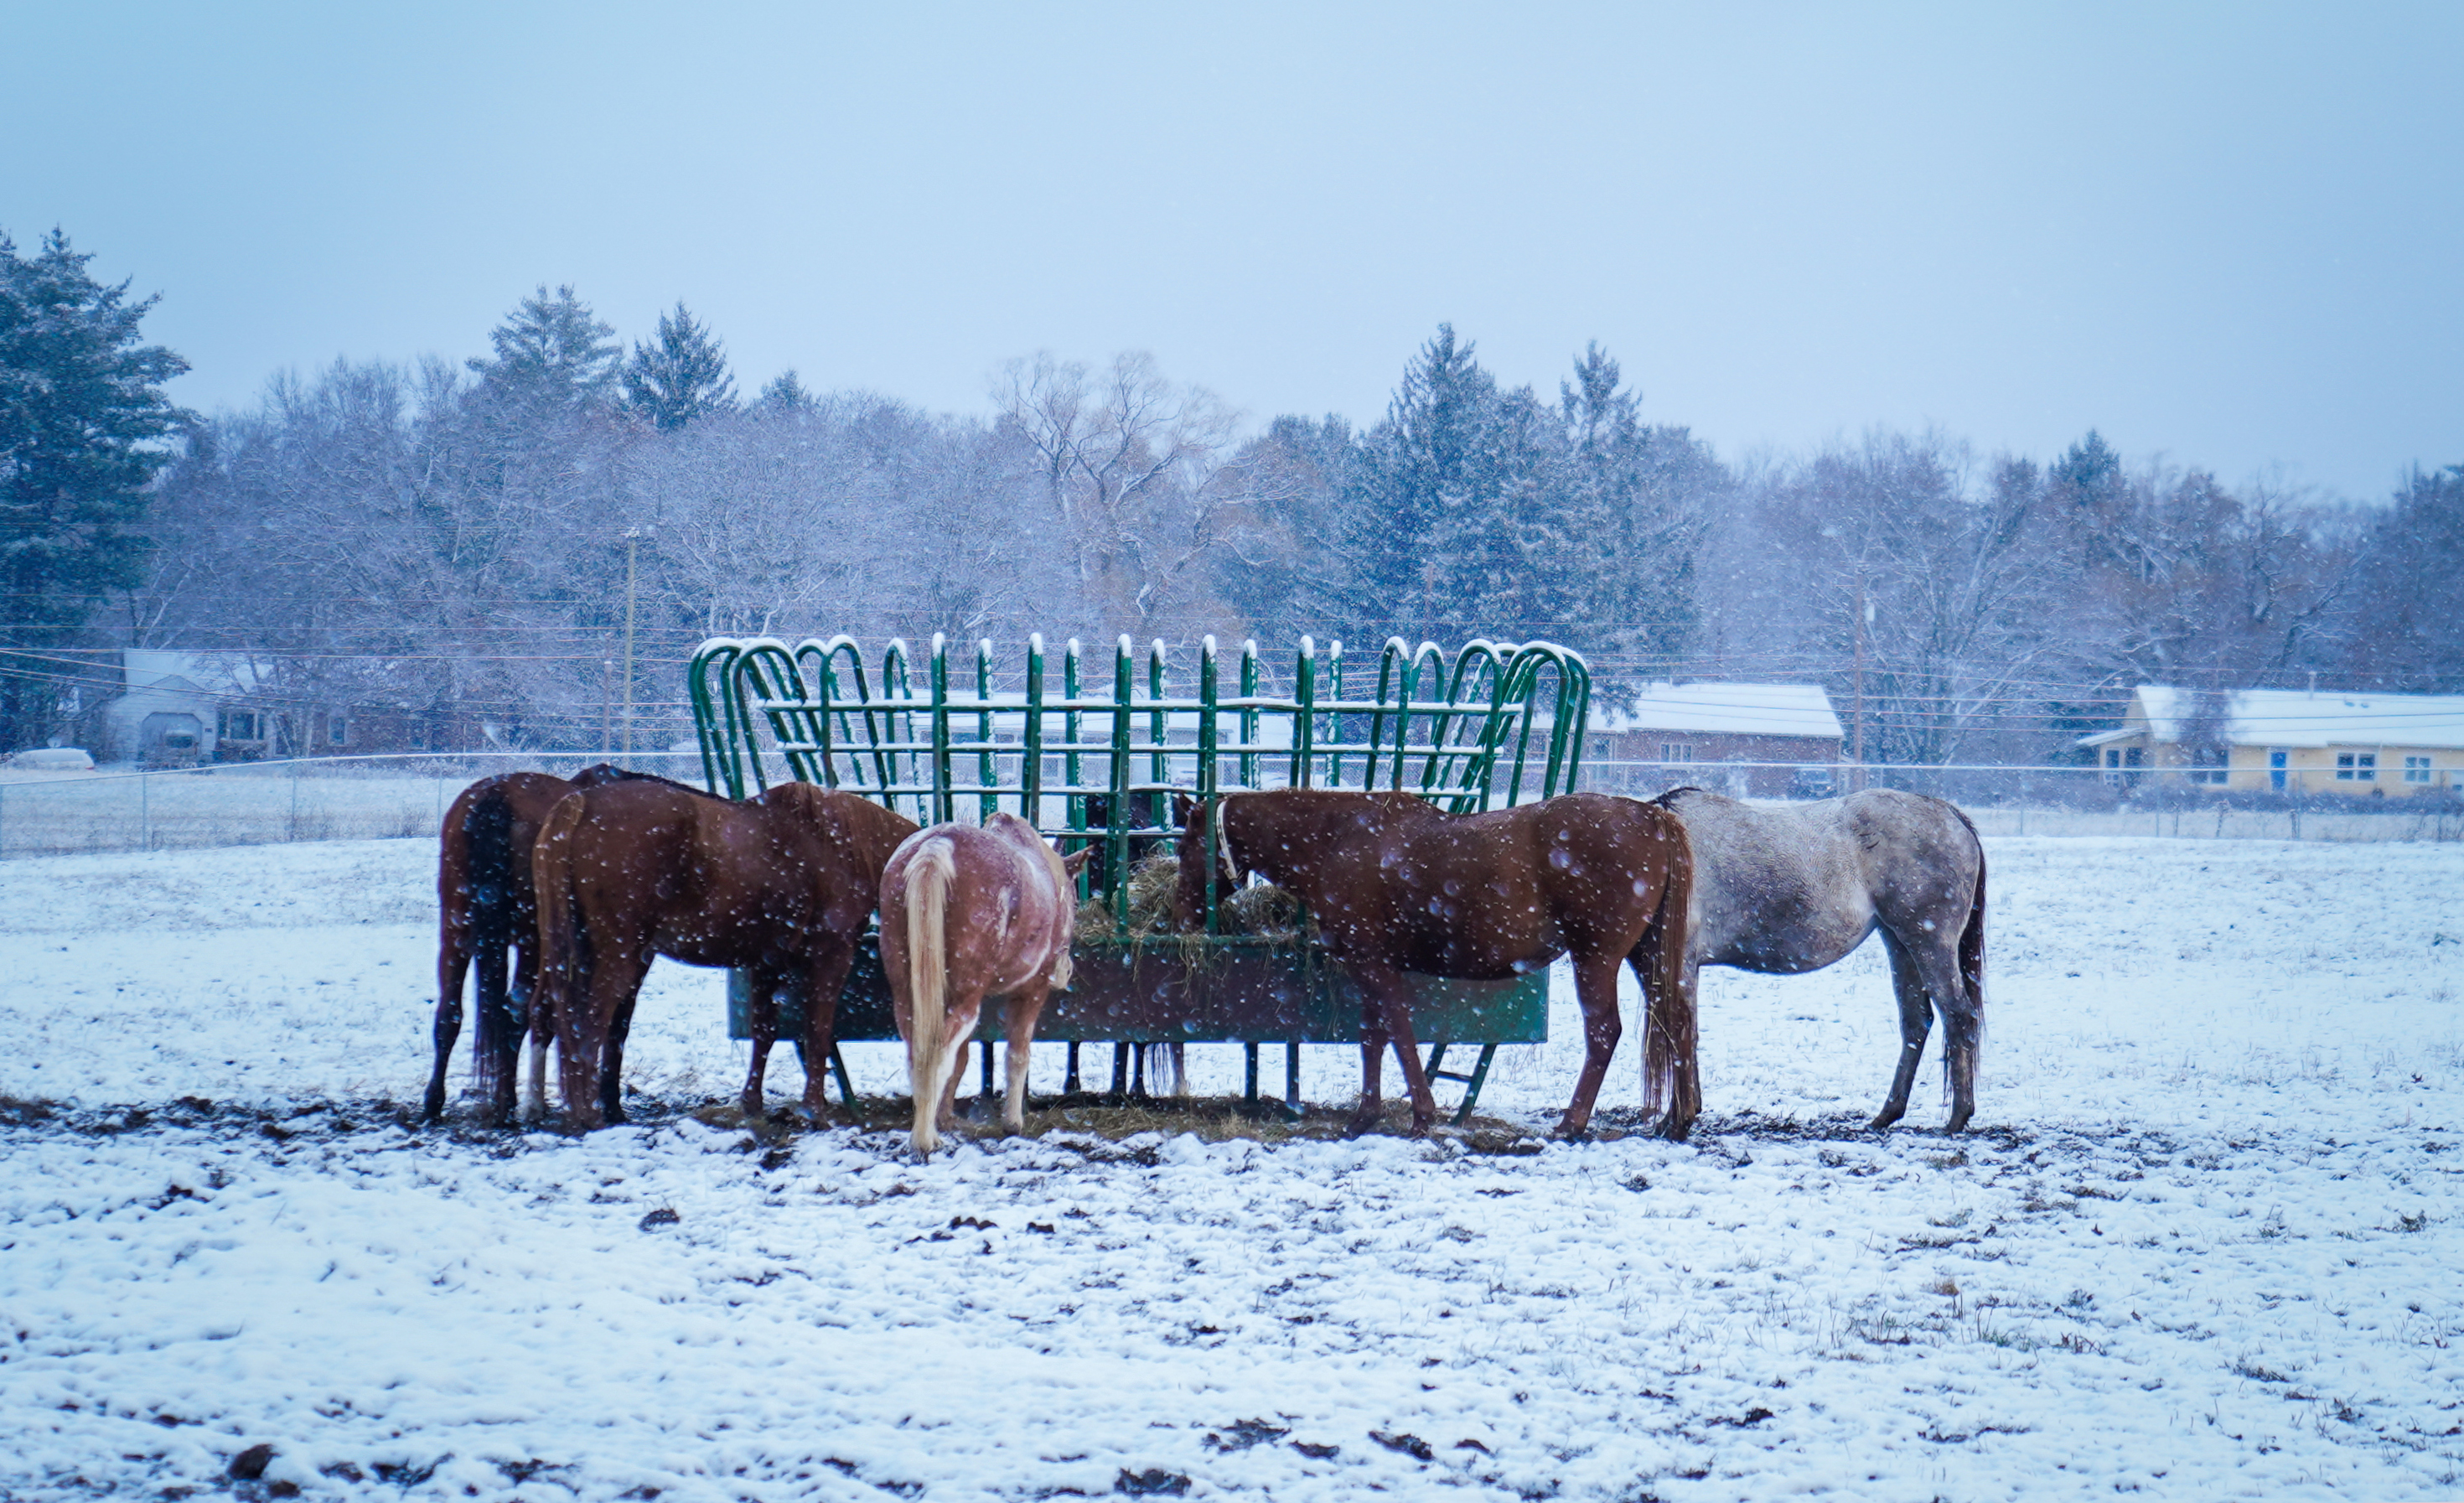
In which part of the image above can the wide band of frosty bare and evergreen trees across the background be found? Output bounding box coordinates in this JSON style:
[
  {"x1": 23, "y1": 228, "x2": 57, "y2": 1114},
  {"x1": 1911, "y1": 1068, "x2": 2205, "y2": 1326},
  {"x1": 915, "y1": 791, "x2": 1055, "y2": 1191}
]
[{"x1": 0, "y1": 231, "x2": 2464, "y2": 761}]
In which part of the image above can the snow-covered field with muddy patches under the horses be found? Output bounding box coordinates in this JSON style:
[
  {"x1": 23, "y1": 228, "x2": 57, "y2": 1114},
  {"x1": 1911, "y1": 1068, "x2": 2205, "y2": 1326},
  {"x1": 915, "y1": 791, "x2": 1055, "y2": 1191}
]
[{"x1": 0, "y1": 837, "x2": 2464, "y2": 1503}]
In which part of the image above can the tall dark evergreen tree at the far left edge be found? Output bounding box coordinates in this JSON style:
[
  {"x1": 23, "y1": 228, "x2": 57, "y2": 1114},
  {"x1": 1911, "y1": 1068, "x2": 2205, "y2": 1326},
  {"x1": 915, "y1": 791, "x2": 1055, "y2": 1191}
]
[{"x1": 0, "y1": 229, "x2": 187, "y2": 749}]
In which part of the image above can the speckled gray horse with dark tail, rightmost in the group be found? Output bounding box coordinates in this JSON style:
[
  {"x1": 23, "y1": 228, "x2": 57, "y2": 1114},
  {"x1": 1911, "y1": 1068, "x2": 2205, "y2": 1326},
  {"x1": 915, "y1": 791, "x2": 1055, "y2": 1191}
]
[{"x1": 1654, "y1": 789, "x2": 1986, "y2": 1133}]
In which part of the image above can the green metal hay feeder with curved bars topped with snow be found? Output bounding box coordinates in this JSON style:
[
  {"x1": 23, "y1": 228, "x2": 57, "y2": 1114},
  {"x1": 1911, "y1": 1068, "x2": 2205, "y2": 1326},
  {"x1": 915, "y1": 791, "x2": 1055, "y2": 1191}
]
[{"x1": 687, "y1": 623, "x2": 1592, "y2": 1121}]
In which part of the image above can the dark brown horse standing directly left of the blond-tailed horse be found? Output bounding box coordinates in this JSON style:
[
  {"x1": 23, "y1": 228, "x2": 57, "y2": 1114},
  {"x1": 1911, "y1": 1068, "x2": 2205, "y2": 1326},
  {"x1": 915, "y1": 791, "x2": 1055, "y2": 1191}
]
[{"x1": 532, "y1": 784, "x2": 914, "y2": 1128}]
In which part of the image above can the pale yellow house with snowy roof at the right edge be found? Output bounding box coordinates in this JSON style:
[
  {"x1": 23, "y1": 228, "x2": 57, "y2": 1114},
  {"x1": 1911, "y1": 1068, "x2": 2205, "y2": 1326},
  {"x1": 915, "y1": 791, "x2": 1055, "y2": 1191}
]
[{"x1": 2077, "y1": 685, "x2": 2464, "y2": 798}]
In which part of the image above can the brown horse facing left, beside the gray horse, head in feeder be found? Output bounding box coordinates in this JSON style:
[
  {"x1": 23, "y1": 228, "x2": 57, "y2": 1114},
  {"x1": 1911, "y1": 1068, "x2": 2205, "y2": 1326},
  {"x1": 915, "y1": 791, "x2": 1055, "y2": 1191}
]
[{"x1": 1178, "y1": 789, "x2": 1703, "y2": 1138}]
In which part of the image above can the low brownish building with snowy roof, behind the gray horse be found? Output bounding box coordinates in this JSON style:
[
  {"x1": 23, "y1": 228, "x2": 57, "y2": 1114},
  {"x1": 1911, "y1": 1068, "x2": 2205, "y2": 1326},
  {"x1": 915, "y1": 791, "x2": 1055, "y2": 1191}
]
[{"x1": 1581, "y1": 682, "x2": 1845, "y2": 798}]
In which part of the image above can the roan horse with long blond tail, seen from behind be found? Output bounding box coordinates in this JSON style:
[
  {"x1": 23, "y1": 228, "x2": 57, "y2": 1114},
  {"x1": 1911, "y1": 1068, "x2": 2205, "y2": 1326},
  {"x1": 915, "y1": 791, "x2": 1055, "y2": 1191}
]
[{"x1": 883, "y1": 813, "x2": 1087, "y2": 1158}]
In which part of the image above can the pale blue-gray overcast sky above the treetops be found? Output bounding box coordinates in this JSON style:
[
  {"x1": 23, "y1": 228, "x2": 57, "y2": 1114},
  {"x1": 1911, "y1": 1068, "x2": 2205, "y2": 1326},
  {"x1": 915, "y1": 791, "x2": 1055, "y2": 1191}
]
[{"x1": 0, "y1": 0, "x2": 2464, "y2": 498}]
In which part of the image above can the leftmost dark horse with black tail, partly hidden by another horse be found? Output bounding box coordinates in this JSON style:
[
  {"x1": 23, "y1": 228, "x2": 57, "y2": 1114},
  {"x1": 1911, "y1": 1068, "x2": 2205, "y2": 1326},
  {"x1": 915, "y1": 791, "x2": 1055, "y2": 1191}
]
[{"x1": 427, "y1": 761, "x2": 682, "y2": 1123}]
